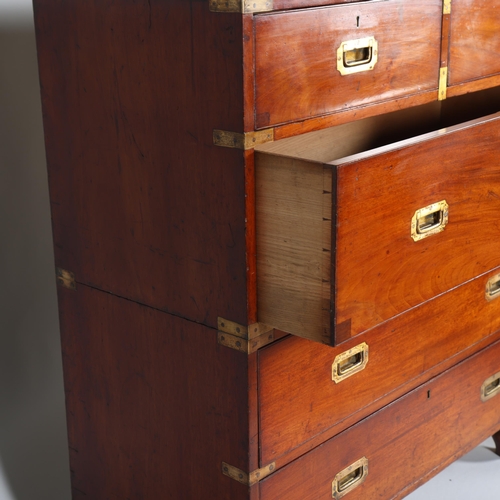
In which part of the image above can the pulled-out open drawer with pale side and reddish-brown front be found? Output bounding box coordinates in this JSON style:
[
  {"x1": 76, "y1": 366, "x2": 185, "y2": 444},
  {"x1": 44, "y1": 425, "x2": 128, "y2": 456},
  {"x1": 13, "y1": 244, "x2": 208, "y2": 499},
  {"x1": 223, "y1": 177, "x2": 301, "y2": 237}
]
[{"x1": 256, "y1": 114, "x2": 500, "y2": 344}]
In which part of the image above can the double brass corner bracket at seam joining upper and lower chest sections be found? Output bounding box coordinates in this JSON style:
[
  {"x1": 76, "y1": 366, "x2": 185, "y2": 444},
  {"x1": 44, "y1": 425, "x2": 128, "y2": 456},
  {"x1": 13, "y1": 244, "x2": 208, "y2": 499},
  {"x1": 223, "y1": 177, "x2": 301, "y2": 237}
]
[{"x1": 217, "y1": 318, "x2": 274, "y2": 354}]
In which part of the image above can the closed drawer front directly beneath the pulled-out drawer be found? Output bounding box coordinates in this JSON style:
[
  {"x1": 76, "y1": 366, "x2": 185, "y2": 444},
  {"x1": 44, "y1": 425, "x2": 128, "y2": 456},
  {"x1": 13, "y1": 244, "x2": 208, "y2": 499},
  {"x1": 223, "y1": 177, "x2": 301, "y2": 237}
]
[{"x1": 259, "y1": 268, "x2": 500, "y2": 464}]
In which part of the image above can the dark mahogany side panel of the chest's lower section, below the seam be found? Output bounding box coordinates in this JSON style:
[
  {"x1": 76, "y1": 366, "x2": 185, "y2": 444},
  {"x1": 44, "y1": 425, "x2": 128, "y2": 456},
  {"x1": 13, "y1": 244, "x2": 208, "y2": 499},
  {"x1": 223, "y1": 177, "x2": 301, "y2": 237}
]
[{"x1": 59, "y1": 285, "x2": 249, "y2": 500}]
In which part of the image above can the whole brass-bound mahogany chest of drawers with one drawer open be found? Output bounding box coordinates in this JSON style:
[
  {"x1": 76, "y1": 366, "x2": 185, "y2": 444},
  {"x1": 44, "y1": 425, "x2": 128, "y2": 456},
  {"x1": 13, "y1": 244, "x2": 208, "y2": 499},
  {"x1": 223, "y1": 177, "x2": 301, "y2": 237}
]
[{"x1": 34, "y1": 0, "x2": 500, "y2": 500}]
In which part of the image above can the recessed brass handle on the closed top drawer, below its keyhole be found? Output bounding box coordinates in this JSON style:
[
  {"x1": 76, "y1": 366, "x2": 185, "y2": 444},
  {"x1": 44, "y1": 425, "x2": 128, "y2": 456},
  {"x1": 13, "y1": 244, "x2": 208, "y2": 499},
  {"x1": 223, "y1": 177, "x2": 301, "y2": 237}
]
[{"x1": 337, "y1": 36, "x2": 378, "y2": 76}]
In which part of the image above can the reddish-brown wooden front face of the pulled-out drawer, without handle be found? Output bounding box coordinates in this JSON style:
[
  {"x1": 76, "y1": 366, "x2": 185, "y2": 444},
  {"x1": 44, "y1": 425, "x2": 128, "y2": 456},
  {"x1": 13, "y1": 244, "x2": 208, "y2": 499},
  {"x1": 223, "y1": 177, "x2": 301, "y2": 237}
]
[{"x1": 332, "y1": 115, "x2": 500, "y2": 335}]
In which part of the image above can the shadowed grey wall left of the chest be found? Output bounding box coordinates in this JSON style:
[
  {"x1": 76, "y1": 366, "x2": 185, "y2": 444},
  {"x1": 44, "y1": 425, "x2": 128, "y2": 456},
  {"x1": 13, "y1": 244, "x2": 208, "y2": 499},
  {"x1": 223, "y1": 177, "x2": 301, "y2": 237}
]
[{"x1": 0, "y1": 19, "x2": 71, "y2": 500}]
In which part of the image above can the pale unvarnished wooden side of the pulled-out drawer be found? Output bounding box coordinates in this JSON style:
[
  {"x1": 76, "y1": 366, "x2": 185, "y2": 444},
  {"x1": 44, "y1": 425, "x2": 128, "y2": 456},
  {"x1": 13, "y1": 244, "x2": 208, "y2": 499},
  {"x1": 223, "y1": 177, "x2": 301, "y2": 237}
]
[{"x1": 256, "y1": 153, "x2": 334, "y2": 344}]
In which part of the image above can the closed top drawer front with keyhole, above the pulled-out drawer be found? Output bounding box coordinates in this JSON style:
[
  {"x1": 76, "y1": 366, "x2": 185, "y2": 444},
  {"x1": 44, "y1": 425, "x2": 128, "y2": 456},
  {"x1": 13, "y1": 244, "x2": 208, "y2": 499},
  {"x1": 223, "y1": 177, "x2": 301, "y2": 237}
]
[{"x1": 255, "y1": 0, "x2": 442, "y2": 128}]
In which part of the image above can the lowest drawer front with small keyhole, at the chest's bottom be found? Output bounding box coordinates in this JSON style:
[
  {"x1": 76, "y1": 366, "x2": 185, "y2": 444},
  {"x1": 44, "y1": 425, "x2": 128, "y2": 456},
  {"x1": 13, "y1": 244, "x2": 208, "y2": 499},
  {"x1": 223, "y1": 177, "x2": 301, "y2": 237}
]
[{"x1": 259, "y1": 342, "x2": 500, "y2": 500}]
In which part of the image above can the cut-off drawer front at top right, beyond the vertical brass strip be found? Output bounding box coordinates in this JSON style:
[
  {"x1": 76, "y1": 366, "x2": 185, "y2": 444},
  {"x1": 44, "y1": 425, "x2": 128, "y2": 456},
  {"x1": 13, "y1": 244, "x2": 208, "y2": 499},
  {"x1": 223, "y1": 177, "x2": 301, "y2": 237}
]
[{"x1": 448, "y1": 0, "x2": 500, "y2": 85}]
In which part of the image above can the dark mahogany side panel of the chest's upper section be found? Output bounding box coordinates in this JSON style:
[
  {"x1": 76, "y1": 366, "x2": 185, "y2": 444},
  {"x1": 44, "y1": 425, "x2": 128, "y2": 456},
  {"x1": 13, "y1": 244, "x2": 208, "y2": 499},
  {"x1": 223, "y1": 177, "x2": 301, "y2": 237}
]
[{"x1": 35, "y1": 0, "x2": 252, "y2": 326}]
